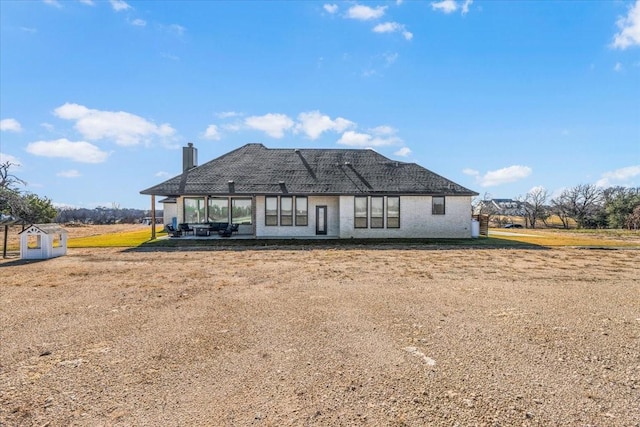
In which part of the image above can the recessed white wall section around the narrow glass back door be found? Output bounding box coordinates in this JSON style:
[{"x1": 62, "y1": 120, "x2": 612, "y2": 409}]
[{"x1": 255, "y1": 196, "x2": 340, "y2": 238}]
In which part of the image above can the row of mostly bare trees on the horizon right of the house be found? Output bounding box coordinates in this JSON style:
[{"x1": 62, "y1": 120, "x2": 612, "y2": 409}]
[{"x1": 475, "y1": 184, "x2": 640, "y2": 230}]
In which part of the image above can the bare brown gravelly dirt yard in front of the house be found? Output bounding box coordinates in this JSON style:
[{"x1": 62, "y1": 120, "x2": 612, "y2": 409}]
[{"x1": 0, "y1": 237, "x2": 640, "y2": 426}]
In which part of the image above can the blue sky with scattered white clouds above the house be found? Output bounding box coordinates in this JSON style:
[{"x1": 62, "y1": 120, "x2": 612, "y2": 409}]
[{"x1": 0, "y1": 0, "x2": 640, "y2": 209}]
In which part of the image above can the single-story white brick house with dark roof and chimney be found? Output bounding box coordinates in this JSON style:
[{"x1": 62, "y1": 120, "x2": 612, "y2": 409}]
[{"x1": 140, "y1": 143, "x2": 478, "y2": 239}]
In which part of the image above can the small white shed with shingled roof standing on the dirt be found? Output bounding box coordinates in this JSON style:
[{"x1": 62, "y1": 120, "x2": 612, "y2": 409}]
[{"x1": 20, "y1": 224, "x2": 67, "y2": 259}]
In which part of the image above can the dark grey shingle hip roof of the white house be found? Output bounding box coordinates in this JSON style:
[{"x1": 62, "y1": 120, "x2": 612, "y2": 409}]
[{"x1": 140, "y1": 144, "x2": 477, "y2": 196}]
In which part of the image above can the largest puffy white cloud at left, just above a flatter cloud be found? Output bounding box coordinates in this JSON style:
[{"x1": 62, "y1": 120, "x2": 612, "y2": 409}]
[{"x1": 54, "y1": 103, "x2": 176, "y2": 145}]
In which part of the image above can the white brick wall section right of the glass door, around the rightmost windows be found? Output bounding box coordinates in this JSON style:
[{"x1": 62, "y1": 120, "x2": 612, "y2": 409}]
[{"x1": 340, "y1": 196, "x2": 471, "y2": 239}]
